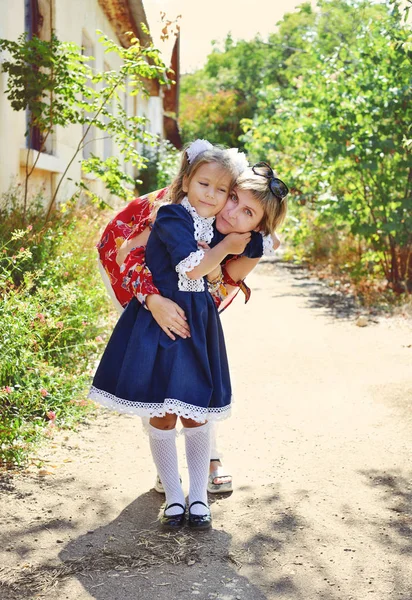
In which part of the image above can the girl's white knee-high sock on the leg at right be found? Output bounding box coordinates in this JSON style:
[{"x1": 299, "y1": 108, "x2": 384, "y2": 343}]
[{"x1": 183, "y1": 423, "x2": 210, "y2": 515}]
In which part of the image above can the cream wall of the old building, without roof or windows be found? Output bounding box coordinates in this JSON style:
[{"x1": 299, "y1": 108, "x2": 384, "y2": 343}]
[{"x1": 0, "y1": 0, "x2": 163, "y2": 200}]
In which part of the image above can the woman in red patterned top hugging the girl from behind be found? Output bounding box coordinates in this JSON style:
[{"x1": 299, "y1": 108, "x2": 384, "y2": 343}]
[{"x1": 98, "y1": 149, "x2": 287, "y2": 493}]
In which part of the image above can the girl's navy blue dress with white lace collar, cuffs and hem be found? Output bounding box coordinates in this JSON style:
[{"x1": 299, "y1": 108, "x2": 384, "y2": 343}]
[{"x1": 89, "y1": 200, "x2": 232, "y2": 422}]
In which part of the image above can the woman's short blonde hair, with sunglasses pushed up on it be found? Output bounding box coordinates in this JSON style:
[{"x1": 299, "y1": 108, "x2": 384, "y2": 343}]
[{"x1": 235, "y1": 167, "x2": 288, "y2": 235}]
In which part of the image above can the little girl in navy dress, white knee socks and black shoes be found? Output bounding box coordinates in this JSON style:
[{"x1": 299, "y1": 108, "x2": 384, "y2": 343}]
[{"x1": 90, "y1": 143, "x2": 251, "y2": 529}]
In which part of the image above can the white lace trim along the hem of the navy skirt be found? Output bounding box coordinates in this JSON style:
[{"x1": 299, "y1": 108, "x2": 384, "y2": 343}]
[{"x1": 88, "y1": 386, "x2": 231, "y2": 423}]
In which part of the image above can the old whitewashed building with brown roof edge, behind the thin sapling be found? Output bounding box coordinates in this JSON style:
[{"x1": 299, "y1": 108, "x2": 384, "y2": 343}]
[{"x1": 0, "y1": 0, "x2": 179, "y2": 200}]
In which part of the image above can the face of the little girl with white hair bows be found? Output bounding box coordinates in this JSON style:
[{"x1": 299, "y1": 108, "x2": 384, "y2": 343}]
[{"x1": 183, "y1": 163, "x2": 232, "y2": 217}]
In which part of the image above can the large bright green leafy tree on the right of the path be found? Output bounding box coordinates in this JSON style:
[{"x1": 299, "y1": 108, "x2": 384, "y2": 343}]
[{"x1": 244, "y1": 0, "x2": 412, "y2": 291}]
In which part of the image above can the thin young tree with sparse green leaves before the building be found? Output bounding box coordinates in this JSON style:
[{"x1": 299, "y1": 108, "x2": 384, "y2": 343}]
[{"x1": 0, "y1": 34, "x2": 169, "y2": 222}]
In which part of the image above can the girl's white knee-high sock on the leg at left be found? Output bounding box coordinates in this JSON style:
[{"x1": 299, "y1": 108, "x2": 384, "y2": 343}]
[{"x1": 149, "y1": 425, "x2": 185, "y2": 516}]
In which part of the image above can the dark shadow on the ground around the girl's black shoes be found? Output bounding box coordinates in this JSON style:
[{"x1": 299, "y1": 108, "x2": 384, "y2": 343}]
[{"x1": 1, "y1": 490, "x2": 266, "y2": 600}]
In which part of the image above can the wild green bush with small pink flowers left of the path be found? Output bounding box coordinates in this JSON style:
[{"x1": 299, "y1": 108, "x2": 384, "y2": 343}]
[{"x1": 0, "y1": 193, "x2": 109, "y2": 466}]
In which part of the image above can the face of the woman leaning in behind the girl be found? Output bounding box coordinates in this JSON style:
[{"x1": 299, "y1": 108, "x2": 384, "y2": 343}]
[{"x1": 216, "y1": 188, "x2": 264, "y2": 235}]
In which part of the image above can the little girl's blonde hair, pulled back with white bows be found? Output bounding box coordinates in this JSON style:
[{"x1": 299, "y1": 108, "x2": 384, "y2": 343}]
[{"x1": 164, "y1": 144, "x2": 238, "y2": 204}]
